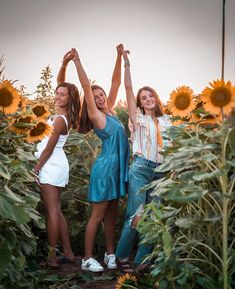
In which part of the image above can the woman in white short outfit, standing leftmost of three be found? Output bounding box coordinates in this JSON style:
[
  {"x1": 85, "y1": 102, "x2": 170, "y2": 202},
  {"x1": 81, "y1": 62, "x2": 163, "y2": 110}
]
[{"x1": 34, "y1": 82, "x2": 80, "y2": 269}]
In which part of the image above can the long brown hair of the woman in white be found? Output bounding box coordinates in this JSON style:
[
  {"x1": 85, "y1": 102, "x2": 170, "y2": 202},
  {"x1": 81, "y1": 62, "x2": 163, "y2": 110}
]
[{"x1": 56, "y1": 82, "x2": 81, "y2": 129}]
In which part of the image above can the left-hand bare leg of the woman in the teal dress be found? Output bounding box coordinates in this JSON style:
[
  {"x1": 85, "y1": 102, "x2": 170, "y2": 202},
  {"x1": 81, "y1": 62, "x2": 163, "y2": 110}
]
[{"x1": 84, "y1": 202, "x2": 108, "y2": 260}]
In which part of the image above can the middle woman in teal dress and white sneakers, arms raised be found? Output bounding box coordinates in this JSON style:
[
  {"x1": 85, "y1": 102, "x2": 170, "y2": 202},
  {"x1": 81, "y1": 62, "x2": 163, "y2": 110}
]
[{"x1": 57, "y1": 44, "x2": 129, "y2": 272}]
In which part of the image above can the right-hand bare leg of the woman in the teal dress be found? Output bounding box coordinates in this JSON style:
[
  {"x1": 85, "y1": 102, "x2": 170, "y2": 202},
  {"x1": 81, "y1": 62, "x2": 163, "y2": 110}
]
[{"x1": 104, "y1": 200, "x2": 118, "y2": 255}]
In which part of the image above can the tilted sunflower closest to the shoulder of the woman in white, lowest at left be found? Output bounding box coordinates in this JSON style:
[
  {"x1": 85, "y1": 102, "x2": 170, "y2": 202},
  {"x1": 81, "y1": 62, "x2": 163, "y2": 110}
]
[{"x1": 26, "y1": 121, "x2": 53, "y2": 143}]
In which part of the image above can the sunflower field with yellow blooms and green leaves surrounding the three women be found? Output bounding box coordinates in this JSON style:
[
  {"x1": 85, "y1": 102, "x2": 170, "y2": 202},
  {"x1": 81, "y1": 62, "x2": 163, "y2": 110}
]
[{"x1": 0, "y1": 53, "x2": 235, "y2": 289}]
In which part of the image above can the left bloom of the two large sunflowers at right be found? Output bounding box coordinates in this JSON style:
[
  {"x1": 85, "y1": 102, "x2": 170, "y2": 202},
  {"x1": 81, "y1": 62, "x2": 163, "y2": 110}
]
[{"x1": 167, "y1": 86, "x2": 196, "y2": 117}]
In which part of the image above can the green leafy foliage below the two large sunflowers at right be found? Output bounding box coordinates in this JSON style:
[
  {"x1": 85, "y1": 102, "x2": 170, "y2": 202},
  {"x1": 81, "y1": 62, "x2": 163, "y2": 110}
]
[{"x1": 139, "y1": 111, "x2": 235, "y2": 289}]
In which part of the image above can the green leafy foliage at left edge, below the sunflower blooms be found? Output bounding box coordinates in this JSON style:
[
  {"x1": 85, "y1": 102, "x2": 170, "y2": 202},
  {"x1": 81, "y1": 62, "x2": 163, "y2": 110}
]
[{"x1": 0, "y1": 64, "x2": 41, "y2": 288}]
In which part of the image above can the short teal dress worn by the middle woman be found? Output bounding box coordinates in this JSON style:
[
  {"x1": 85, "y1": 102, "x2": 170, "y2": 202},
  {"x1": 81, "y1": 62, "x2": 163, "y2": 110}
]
[{"x1": 88, "y1": 114, "x2": 129, "y2": 203}]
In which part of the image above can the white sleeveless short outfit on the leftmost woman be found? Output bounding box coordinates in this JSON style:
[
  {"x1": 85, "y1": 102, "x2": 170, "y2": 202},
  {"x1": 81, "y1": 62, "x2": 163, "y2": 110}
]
[{"x1": 35, "y1": 115, "x2": 69, "y2": 187}]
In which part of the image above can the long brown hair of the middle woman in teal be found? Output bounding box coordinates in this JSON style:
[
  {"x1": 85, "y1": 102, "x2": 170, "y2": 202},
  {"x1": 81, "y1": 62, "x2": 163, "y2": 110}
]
[{"x1": 78, "y1": 84, "x2": 107, "y2": 134}]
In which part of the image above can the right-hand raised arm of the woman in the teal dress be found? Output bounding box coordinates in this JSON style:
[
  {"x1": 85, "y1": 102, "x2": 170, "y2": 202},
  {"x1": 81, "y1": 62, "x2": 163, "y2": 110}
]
[{"x1": 108, "y1": 44, "x2": 124, "y2": 109}]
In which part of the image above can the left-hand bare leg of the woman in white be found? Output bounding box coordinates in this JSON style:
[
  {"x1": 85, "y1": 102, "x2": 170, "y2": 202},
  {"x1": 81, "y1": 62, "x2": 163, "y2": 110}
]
[{"x1": 42, "y1": 184, "x2": 60, "y2": 266}]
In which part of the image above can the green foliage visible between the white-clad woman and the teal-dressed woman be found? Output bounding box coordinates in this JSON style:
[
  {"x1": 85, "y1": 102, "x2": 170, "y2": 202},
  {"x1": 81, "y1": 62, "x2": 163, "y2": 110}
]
[{"x1": 62, "y1": 131, "x2": 101, "y2": 254}]
